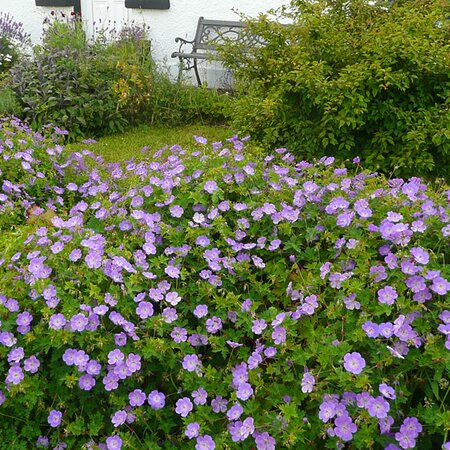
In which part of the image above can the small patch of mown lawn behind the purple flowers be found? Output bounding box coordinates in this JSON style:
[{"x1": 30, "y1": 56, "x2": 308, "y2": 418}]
[{"x1": 66, "y1": 125, "x2": 233, "y2": 162}]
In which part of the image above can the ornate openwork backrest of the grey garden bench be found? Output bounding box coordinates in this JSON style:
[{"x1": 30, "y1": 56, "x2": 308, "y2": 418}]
[{"x1": 194, "y1": 17, "x2": 259, "y2": 51}]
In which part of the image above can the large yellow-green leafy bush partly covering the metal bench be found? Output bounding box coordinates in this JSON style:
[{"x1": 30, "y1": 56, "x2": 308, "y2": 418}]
[{"x1": 223, "y1": 0, "x2": 450, "y2": 178}]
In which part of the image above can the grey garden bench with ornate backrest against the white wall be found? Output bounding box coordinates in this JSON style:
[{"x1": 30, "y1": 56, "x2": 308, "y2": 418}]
[{"x1": 172, "y1": 17, "x2": 262, "y2": 86}]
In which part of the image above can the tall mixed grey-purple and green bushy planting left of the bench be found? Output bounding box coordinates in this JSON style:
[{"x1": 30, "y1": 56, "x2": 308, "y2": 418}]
[{"x1": 12, "y1": 16, "x2": 154, "y2": 139}]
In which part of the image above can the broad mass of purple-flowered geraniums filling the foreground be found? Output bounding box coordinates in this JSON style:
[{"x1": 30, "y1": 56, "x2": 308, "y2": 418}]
[{"x1": 0, "y1": 120, "x2": 450, "y2": 450}]
